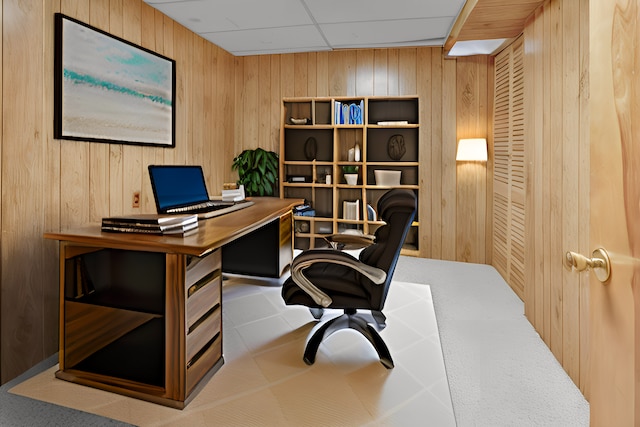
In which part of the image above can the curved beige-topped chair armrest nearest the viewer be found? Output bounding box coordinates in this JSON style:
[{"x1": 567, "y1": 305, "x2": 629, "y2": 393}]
[{"x1": 291, "y1": 249, "x2": 387, "y2": 307}]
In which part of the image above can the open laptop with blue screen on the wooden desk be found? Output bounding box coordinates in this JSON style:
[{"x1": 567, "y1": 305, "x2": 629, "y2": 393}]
[{"x1": 149, "y1": 165, "x2": 253, "y2": 219}]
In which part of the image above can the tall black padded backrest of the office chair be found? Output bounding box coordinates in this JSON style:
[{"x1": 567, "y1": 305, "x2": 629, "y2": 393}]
[{"x1": 360, "y1": 188, "x2": 417, "y2": 310}]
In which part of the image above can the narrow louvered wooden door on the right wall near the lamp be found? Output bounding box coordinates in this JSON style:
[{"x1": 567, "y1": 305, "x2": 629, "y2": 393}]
[{"x1": 493, "y1": 37, "x2": 525, "y2": 298}]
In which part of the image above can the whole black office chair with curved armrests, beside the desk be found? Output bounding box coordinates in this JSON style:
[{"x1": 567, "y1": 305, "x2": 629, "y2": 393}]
[{"x1": 282, "y1": 189, "x2": 416, "y2": 369}]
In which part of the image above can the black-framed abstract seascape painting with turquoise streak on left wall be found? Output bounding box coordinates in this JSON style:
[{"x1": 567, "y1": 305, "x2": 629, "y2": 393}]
[{"x1": 54, "y1": 13, "x2": 176, "y2": 147}]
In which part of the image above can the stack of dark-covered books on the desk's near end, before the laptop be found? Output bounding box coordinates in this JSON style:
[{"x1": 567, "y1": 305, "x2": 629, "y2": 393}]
[{"x1": 102, "y1": 214, "x2": 198, "y2": 235}]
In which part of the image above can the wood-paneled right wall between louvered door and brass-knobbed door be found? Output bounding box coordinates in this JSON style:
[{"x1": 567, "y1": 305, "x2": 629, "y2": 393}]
[{"x1": 524, "y1": 0, "x2": 591, "y2": 395}]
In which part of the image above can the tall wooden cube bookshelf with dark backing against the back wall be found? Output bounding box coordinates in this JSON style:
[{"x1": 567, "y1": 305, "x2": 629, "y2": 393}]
[{"x1": 280, "y1": 96, "x2": 420, "y2": 255}]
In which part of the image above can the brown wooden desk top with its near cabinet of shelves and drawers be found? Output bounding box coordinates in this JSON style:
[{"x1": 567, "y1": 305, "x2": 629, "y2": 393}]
[{"x1": 44, "y1": 198, "x2": 302, "y2": 409}]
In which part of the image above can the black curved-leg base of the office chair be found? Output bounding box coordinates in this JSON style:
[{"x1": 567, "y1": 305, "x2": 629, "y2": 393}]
[{"x1": 303, "y1": 309, "x2": 394, "y2": 369}]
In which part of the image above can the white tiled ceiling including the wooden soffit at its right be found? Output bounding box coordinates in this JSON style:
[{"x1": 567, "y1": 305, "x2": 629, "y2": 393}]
[{"x1": 144, "y1": 0, "x2": 544, "y2": 56}]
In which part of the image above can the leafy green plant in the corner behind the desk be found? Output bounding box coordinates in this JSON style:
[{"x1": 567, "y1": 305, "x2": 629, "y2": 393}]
[{"x1": 231, "y1": 148, "x2": 278, "y2": 196}]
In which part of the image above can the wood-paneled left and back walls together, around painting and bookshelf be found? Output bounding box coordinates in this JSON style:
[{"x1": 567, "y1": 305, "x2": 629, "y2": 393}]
[{"x1": 0, "y1": 0, "x2": 492, "y2": 383}]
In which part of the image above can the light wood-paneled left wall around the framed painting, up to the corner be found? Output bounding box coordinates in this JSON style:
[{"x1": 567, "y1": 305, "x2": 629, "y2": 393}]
[{"x1": 0, "y1": 0, "x2": 235, "y2": 383}]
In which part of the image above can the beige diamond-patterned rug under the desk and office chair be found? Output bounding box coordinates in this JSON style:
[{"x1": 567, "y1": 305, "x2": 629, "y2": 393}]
[{"x1": 10, "y1": 278, "x2": 456, "y2": 427}]
